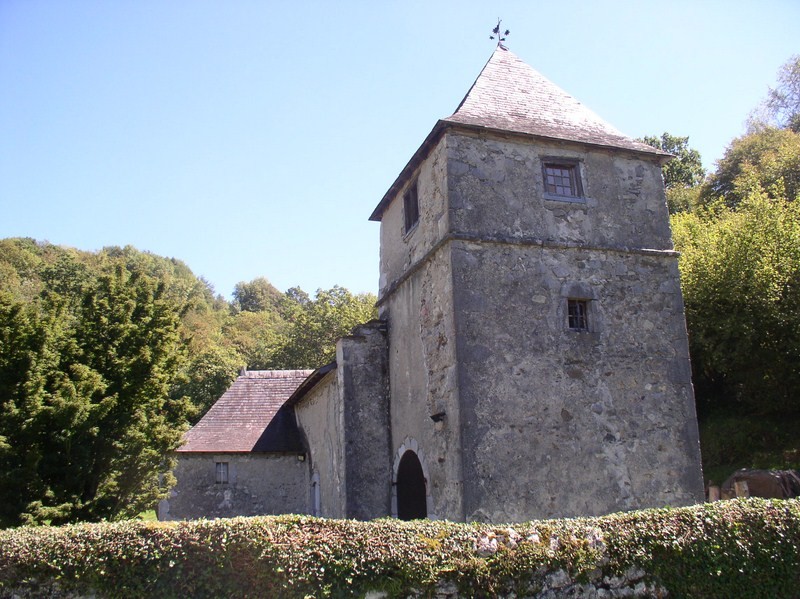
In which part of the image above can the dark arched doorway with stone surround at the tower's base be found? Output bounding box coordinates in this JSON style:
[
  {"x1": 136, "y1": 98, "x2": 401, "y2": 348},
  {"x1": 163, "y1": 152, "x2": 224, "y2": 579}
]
[{"x1": 392, "y1": 437, "x2": 436, "y2": 520}]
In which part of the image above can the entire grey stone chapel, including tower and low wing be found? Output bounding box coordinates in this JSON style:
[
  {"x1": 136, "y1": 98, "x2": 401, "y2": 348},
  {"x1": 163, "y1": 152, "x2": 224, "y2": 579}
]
[{"x1": 159, "y1": 46, "x2": 703, "y2": 522}]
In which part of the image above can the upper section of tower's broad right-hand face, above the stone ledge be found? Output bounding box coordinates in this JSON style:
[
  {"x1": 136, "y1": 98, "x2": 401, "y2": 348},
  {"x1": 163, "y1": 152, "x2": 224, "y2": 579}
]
[{"x1": 446, "y1": 134, "x2": 672, "y2": 250}]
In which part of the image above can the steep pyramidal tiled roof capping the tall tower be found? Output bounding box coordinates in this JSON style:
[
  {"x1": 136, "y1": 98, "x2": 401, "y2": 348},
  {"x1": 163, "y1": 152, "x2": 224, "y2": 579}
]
[{"x1": 370, "y1": 46, "x2": 670, "y2": 220}]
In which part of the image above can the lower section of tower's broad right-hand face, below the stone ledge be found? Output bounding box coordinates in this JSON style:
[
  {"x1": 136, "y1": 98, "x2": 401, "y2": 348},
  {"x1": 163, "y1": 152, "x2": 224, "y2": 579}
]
[{"x1": 453, "y1": 243, "x2": 703, "y2": 522}]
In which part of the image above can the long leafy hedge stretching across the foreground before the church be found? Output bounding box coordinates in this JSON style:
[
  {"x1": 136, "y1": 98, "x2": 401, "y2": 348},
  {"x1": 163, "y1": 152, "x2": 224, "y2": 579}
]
[{"x1": 0, "y1": 499, "x2": 800, "y2": 598}]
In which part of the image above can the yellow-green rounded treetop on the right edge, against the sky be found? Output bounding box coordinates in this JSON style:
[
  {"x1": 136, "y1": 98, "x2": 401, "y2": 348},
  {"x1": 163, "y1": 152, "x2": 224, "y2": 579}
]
[{"x1": 700, "y1": 127, "x2": 800, "y2": 208}]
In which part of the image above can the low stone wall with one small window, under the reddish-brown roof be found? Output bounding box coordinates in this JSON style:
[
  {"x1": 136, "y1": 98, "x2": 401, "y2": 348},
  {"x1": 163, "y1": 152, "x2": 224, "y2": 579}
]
[{"x1": 158, "y1": 454, "x2": 309, "y2": 520}]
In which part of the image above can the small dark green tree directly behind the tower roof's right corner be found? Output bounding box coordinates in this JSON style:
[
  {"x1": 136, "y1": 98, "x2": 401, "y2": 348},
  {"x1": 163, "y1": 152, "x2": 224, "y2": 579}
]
[{"x1": 641, "y1": 131, "x2": 706, "y2": 214}]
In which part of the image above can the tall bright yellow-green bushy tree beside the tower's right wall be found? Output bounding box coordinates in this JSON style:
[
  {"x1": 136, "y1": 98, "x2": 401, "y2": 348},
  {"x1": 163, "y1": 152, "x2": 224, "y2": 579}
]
[{"x1": 672, "y1": 192, "x2": 800, "y2": 414}]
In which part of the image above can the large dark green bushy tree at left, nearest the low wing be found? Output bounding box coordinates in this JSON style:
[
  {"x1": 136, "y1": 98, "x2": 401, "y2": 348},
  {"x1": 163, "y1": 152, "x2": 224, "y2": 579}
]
[{"x1": 0, "y1": 265, "x2": 189, "y2": 526}]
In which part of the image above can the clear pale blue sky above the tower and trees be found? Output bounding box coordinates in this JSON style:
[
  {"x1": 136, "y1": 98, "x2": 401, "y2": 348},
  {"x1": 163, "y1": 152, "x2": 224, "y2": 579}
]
[{"x1": 0, "y1": 0, "x2": 800, "y2": 296}]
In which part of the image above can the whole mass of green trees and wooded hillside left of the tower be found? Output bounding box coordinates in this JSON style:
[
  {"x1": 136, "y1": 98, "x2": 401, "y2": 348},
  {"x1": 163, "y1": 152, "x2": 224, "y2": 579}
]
[{"x1": 0, "y1": 239, "x2": 375, "y2": 526}]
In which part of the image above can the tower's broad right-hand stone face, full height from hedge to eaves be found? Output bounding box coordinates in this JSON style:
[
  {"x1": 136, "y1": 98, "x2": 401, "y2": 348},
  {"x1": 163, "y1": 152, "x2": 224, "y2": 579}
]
[{"x1": 447, "y1": 131, "x2": 703, "y2": 522}]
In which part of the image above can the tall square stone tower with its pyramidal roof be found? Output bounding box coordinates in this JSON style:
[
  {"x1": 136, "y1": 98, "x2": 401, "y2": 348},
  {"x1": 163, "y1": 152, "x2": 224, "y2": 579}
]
[{"x1": 371, "y1": 46, "x2": 703, "y2": 522}]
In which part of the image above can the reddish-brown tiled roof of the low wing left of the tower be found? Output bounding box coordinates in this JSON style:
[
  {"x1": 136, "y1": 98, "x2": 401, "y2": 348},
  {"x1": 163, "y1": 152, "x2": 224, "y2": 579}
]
[{"x1": 178, "y1": 370, "x2": 313, "y2": 453}]
